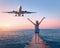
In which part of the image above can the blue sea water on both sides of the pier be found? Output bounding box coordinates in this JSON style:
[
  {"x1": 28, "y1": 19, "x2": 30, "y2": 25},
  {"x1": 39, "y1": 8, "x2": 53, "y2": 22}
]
[{"x1": 0, "y1": 29, "x2": 60, "y2": 48}]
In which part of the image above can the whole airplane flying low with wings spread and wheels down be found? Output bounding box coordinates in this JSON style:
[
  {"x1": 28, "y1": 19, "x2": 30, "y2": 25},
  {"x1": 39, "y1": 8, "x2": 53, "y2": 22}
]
[{"x1": 3, "y1": 6, "x2": 36, "y2": 16}]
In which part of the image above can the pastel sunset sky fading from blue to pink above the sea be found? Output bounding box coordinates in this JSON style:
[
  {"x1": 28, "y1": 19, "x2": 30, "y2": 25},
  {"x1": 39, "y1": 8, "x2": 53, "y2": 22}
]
[{"x1": 0, "y1": 0, "x2": 60, "y2": 30}]
